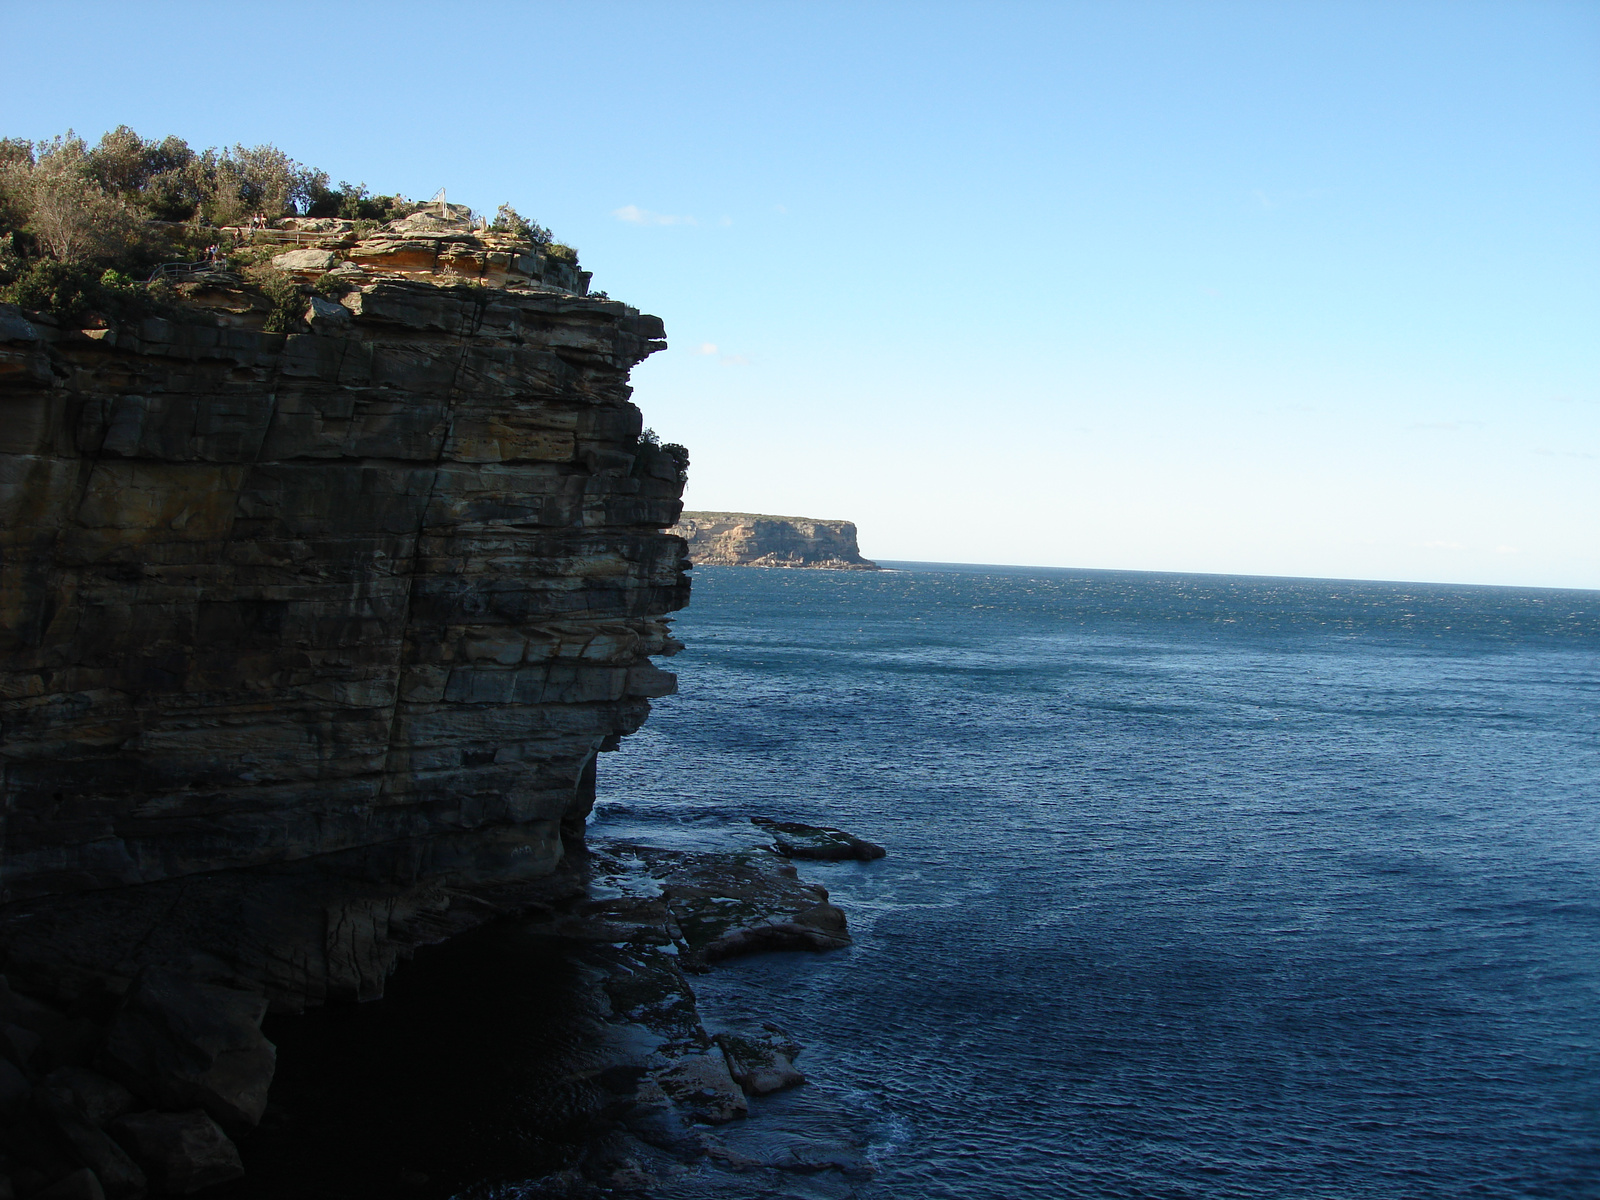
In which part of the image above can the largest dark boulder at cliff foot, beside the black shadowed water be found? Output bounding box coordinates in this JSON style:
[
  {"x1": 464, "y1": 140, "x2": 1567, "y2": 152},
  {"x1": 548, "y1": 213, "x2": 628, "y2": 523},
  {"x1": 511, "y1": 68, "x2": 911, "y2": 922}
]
[{"x1": 99, "y1": 968, "x2": 277, "y2": 1125}]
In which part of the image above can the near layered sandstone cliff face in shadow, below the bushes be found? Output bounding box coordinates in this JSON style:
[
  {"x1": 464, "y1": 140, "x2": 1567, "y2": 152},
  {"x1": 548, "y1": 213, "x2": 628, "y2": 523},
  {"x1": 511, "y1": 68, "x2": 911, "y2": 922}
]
[{"x1": 0, "y1": 218, "x2": 688, "y2": 1006}]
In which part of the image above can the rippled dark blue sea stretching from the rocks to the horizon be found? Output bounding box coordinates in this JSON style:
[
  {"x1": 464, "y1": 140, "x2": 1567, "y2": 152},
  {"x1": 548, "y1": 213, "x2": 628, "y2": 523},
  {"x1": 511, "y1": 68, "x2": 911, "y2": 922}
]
[{"x1": 595, "y1": 565, "x2": 1600, "y2": 1200}]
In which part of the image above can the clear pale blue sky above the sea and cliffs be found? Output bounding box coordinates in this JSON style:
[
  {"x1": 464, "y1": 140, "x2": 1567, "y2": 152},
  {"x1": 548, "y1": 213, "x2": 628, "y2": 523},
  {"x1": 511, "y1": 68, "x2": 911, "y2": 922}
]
[{"x1": 0, "y1": 0, "x2": 1600, "y2": 587}]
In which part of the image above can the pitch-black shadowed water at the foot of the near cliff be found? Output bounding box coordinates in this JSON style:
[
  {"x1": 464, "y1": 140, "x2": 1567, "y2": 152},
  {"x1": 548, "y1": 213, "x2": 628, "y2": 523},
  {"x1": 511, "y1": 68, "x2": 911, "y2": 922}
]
[{"x1": 219, "y1": 922, "x2": 597, "y2": 1200}]
